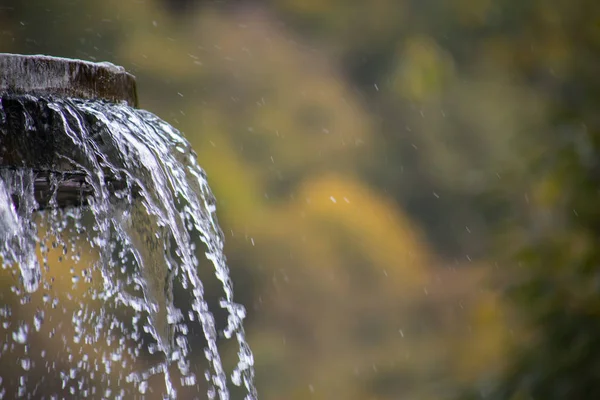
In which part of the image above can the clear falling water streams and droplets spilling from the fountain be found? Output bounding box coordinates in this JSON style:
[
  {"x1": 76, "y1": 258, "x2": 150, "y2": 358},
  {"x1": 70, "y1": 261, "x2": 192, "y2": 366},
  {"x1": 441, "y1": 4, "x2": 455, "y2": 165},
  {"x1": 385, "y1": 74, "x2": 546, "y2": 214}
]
[{"x1": 0, "y1": 95, "x2": 257, "y2": 400}]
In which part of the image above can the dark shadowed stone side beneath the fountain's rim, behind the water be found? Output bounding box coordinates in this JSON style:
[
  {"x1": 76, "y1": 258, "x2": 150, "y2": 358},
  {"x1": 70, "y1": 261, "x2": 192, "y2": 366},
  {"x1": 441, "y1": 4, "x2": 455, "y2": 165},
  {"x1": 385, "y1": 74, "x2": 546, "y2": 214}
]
[{"x1": 0, "y1": 93, "x2": 125, "y2": 209}]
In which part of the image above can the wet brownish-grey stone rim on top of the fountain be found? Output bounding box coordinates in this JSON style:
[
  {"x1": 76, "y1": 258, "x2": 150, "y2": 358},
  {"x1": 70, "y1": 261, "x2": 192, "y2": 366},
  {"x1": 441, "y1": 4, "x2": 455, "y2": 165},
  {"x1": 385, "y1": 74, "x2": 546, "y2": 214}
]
[{"x1": 0, "y1": 53, "x2": 138, "y2": 107}]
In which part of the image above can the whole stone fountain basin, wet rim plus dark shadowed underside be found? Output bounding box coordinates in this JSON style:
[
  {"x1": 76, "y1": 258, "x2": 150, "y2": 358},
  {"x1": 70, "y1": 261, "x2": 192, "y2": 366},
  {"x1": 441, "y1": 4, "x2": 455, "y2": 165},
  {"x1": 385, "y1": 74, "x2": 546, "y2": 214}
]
[{"x1": 0, "y1": 53, "x2": 138, "y2": 209}]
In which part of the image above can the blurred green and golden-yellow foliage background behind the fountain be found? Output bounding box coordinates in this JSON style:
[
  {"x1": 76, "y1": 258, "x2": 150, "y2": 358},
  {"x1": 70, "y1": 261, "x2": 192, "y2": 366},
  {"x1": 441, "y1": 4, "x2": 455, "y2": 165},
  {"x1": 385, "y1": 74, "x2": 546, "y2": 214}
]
[{"x1": 0, "y1": 0, "x2": 600, "y2": 400}]
